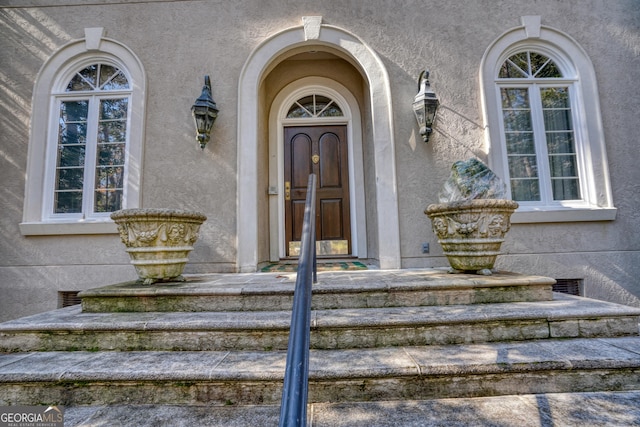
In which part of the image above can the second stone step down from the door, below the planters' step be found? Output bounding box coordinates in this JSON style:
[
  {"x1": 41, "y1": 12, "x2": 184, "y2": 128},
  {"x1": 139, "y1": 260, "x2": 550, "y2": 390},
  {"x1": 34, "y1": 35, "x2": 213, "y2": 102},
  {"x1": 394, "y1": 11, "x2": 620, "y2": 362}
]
[{"x1": 0, "y1": 294, "x2": 640, "y2": 352}]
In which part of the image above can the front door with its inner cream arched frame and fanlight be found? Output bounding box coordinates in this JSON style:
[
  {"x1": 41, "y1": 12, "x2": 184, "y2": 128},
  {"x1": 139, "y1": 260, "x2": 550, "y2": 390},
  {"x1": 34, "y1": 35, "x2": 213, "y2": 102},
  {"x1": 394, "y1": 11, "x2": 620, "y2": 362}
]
[{"x1": 269, "y1": 77, "x2": 367, "y2": 261}]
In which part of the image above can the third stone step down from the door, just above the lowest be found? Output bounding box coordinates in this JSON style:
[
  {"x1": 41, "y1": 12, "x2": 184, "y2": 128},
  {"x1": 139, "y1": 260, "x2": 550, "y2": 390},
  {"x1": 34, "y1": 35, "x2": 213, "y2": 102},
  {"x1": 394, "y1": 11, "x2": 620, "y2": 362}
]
[{"x1": 0, "y1": 336, "x2": 640, "y2": 406}]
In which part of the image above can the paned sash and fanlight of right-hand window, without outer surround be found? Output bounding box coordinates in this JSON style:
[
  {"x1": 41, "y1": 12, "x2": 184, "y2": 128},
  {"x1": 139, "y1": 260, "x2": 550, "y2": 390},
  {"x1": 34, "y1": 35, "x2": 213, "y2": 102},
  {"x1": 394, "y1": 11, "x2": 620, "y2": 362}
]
[{"x1": 496, "y1": 50, "x2": 582, "y2": 204}]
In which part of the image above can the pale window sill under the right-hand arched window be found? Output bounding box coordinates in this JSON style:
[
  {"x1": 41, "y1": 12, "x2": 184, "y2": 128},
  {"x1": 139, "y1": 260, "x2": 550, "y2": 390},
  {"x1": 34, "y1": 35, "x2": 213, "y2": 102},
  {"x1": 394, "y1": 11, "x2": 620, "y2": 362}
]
[{"x1": 511, "y1": 208, "x2": 618, "y2": 224}]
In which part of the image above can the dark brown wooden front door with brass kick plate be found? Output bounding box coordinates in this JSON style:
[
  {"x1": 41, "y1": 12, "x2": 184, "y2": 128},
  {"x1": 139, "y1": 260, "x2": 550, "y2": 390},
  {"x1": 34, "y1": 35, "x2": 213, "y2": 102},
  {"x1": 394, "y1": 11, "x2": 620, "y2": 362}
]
[{"x1": 284, "y1": 125, "x2": 351, "y2": 257}]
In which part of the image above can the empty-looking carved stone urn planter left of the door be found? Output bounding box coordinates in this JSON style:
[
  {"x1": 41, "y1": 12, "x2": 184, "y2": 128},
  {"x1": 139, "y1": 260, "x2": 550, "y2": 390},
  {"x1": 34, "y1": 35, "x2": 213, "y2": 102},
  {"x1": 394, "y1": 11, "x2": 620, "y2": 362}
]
[{"x1": 111, "y1": 209, "x2": 207, "y2": 285}]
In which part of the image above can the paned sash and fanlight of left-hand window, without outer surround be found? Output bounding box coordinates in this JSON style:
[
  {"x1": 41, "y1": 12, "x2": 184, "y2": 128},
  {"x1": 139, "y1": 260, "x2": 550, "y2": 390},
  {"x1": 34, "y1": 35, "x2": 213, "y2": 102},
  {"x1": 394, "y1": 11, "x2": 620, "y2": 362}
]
[{"x1": 46, "y1": 63, "x2": 132, "y2": 218}]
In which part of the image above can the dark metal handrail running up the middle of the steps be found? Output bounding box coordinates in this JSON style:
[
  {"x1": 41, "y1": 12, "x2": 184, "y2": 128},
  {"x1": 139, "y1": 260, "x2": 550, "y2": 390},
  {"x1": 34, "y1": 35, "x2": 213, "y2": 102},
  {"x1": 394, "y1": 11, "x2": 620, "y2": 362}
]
[{"x1": 279, "y1": 174, "x2": 318, "y2": 427}]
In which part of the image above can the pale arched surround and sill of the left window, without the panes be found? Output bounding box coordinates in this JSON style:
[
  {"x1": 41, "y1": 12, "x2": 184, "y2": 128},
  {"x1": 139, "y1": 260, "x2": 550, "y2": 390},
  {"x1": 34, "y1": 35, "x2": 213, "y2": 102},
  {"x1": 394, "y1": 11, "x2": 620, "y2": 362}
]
[{"x1": 20, "y1": 28, "x2": 146, "y2": 235}]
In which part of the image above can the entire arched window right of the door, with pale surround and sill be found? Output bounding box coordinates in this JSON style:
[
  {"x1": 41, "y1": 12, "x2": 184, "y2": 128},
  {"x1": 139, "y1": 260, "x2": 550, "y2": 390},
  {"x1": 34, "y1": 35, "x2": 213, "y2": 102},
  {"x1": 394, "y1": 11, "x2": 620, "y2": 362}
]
[{"x1": 480, "y1": 16, "x2": 616, "y2": 222}]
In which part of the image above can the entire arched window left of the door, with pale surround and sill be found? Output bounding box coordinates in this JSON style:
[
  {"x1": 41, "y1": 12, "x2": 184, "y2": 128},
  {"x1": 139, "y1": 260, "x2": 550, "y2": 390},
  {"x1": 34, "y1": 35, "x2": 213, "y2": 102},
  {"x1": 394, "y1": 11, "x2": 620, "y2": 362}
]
[{"x1": 20, "y1": 28, "x2": 146, "y2": 235}]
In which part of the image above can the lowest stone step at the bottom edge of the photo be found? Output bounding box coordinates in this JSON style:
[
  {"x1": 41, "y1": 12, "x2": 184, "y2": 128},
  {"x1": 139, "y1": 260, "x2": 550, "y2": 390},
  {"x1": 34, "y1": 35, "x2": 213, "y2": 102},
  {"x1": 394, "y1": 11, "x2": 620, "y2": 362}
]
[{"x1": 64, "y1": 391, "x2": 640, "y2": 427}]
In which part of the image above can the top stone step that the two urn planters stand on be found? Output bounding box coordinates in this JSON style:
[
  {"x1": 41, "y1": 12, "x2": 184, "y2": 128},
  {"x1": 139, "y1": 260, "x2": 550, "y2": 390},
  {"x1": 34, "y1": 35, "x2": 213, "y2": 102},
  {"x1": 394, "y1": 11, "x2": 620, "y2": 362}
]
[{"x1": 80, "y1": 269, "x2": 555, "y2": 313}]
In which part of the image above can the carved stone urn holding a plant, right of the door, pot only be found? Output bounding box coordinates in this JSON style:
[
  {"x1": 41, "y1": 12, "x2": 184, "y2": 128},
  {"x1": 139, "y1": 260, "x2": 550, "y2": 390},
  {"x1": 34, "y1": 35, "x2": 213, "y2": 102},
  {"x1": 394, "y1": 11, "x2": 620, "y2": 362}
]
[{"x1": 425, "y1": 199, "x2": 518, "y2": 275}]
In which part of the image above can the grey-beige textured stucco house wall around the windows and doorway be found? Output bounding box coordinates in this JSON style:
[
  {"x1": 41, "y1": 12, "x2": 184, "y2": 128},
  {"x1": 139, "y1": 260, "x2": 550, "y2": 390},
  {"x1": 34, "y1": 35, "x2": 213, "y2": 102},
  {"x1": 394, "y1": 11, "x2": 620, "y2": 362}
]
[{"x1": 0, "y1": 0, "x2": 640, "y2": 320}]
